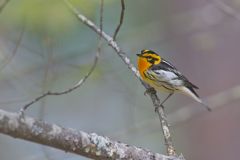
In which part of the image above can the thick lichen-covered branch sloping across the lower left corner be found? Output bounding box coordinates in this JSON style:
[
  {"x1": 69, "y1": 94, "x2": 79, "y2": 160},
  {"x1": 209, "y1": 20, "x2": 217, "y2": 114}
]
[{"x1": 0, "y1": 110, "x2": 181, "y2": 160}]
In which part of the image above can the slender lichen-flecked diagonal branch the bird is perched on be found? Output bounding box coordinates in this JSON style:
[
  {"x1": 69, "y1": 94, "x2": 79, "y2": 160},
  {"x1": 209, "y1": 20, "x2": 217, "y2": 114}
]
[{"x1": 64, "y1": 0, "x2": 176, "y2": 156}]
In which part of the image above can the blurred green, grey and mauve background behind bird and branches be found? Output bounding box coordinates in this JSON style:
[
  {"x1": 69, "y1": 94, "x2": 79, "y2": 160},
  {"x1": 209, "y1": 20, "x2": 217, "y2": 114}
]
[{"x1": 0, "y1": 0, "x2": 240, "y2": 160}]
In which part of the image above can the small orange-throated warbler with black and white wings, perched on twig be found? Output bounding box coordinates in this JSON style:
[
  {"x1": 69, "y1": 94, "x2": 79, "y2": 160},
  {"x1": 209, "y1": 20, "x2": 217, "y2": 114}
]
[{"x1": 137, "y1": 50, "x2": 211, "y2": 111}]
